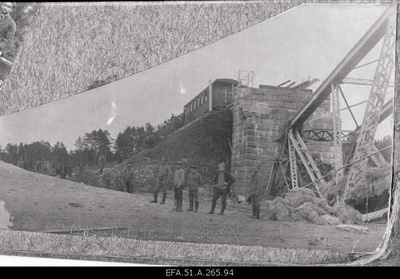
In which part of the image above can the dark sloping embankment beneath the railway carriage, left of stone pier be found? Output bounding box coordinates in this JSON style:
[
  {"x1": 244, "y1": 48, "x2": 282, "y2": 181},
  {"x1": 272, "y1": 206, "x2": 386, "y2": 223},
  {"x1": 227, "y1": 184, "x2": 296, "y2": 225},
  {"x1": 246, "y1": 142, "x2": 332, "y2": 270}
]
[{"x1": 98, "y1": 109, "x2": 232, "y2": 192}]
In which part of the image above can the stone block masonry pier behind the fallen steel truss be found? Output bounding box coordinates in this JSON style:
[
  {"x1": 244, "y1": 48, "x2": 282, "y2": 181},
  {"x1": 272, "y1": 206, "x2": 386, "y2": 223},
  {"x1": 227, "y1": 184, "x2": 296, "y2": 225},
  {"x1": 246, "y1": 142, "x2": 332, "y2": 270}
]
[{"x1": 231, "y1": 86, "x2": 334, "y2": 195}]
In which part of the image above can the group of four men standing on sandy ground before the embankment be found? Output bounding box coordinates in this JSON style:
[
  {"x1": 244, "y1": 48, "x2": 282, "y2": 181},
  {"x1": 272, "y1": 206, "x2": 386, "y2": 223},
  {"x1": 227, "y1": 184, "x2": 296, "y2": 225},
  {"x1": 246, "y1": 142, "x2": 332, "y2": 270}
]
[{"x1": 150, "y1": 157, "x2": 235, "y2": 215}]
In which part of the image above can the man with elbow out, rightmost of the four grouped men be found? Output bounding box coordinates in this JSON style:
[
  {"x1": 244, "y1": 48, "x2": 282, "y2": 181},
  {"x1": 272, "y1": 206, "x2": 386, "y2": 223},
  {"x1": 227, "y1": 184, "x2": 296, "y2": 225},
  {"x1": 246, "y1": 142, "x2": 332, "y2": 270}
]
[{"x1": 208, "y1": 163, "x2": 235, "y2": 215}]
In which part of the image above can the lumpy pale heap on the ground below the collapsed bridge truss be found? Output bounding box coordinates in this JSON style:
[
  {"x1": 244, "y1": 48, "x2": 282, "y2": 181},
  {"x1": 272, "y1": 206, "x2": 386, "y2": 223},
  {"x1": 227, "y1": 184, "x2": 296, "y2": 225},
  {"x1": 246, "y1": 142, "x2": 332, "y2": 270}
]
[{"x1": 260, "y1": 188, "x2": 362, "y2": 225}]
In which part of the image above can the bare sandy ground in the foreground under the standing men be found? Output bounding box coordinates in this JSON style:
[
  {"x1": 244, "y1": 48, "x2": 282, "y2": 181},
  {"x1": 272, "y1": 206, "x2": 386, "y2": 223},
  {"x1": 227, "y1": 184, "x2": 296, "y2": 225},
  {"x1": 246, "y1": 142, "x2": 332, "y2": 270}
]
[{"x1": 0, "y1": 162, "x2": 386, "y2": 252}]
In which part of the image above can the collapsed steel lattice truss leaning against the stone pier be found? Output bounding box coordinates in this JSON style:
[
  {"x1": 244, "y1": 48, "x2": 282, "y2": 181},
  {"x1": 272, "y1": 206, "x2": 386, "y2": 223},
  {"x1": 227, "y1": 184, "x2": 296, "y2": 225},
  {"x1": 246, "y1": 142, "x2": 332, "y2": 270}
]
[{"x1": 268, "y1": 6, "x2": 396, "y2": 202}]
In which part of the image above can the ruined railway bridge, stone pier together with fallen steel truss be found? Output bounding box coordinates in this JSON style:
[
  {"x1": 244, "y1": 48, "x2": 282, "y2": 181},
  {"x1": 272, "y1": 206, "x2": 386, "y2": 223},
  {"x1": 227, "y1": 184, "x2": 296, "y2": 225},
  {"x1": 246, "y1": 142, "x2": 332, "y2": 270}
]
[{"x1": 231, "y1": 7, "x2": 396, "y2": 202}]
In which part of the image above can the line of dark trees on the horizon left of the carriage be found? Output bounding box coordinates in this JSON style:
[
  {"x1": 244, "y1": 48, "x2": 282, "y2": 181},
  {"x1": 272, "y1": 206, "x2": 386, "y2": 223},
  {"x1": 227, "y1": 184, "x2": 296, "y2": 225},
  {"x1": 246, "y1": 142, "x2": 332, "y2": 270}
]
[{"x1": 0, "y1": 116, "x2": 183, "y2": 173}]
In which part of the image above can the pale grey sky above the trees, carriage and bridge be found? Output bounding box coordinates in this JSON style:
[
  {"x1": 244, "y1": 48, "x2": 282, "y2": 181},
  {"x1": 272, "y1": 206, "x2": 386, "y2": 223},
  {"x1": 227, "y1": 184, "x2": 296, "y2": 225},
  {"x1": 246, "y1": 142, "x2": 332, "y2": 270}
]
[{"x1": 0, "y1": 3, "x2": 393, "y2": 150}]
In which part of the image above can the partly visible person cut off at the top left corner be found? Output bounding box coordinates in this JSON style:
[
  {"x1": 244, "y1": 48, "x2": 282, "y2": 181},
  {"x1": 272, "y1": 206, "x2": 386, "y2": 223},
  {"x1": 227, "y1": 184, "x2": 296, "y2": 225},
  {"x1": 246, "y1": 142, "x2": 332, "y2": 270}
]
[{"x1": 0, "y1": 2, "x2": 17, "y2": 89}]
